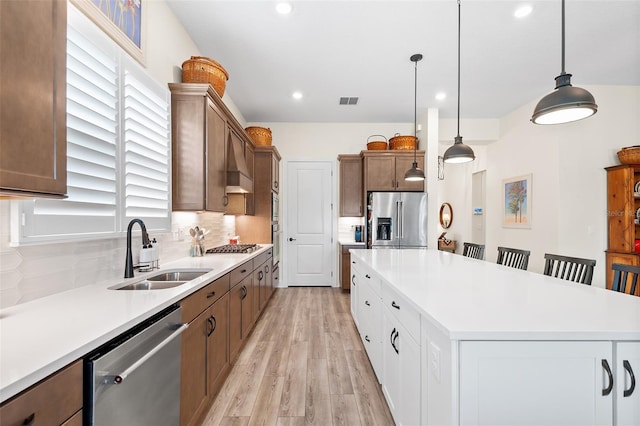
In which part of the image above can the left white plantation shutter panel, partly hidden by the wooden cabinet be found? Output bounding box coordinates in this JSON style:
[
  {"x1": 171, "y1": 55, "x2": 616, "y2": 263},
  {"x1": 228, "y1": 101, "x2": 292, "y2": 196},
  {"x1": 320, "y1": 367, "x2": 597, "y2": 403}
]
[{"x1": 23, "y1": 12, "x2": 118, "y2": 237}]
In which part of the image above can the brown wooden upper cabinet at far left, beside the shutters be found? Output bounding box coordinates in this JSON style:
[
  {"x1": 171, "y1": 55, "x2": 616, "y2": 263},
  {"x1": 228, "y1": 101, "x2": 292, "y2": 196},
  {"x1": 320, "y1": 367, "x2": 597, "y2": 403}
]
[{"x1": 0, "y1": 0, "x2": 67, "y2": 198}]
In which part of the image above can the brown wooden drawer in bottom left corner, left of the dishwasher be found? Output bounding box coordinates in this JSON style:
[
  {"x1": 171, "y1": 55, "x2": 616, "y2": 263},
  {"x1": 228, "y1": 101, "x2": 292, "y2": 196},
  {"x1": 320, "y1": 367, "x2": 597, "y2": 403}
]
[{"x1": 0, "y1": 360, "x2": 82, "y2": 426}]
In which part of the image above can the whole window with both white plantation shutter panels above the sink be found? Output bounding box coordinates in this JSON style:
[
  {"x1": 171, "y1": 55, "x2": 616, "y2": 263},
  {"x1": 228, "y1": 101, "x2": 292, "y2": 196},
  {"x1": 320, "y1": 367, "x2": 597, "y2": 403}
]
[{"x1": 12, "y1": 4, "x2": 171, "y2": 244}]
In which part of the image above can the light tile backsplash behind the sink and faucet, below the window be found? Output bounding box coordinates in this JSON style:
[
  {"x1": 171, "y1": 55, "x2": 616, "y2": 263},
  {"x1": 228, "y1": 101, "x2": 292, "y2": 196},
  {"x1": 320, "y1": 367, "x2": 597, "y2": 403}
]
[{"x1": 0, "y1": 200, "x2": 235, "y2": 308}]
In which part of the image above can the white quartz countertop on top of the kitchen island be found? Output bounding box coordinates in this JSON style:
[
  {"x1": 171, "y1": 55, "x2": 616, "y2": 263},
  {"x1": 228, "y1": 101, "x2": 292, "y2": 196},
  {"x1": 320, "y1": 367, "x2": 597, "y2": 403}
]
[{"x1": 350, "y1": 249, "x2": 640, "y2": 340}]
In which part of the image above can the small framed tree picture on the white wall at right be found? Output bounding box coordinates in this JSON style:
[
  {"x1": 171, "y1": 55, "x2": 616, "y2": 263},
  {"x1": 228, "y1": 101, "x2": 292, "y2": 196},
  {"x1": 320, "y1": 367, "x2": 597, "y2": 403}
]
[{"x1": 502, "y1": 174, "x2": 532, "y2": 228}]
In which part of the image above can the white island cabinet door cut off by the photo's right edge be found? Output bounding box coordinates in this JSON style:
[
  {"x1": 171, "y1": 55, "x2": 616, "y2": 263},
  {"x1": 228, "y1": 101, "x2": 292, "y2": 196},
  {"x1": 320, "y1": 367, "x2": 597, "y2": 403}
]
[{"x1": 615, "y1": 342, "x2": 640, "y2": 426}]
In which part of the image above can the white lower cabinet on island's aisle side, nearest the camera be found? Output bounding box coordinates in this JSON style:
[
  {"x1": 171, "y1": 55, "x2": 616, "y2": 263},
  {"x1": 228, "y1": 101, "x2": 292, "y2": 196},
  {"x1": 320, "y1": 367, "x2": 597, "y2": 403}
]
[{"x1": 382, "y1": 307, "x2": 421, "y2": 425}]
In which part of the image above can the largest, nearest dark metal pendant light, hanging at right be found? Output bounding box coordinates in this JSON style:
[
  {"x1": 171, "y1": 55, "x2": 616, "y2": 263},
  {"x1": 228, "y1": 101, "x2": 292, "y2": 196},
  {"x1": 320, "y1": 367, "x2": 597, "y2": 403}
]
[{"x1": 531, "y1": 0, "x2": 598, "y2": 124}]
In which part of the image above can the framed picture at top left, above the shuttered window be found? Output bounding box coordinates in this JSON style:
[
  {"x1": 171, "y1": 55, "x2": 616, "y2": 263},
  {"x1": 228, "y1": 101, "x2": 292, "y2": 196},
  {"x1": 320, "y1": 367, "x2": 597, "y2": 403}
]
[{"x1": 71, "y1": 0, "x2": 148, "y2": 65}]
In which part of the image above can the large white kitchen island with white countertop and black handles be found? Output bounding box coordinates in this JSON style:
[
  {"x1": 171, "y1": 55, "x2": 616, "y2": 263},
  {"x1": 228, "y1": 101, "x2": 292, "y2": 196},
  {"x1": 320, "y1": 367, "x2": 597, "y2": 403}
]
[{"x1": 351, "y1": 250, "x2": 640, "y2": 426}]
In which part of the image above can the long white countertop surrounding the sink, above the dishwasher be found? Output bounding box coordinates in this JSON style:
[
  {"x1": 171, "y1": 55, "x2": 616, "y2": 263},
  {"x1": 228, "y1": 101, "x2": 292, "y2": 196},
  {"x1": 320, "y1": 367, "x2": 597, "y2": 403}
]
[{"x1": 0, "y1": 244, "x2": 271, "y2": 401}]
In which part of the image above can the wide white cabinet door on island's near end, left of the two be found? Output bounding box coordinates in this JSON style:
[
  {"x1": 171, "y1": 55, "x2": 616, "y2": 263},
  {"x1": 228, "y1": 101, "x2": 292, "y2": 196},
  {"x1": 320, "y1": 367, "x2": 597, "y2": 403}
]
[{"x1": 459, "y1": 341, "x2": 614, "y2": 426}]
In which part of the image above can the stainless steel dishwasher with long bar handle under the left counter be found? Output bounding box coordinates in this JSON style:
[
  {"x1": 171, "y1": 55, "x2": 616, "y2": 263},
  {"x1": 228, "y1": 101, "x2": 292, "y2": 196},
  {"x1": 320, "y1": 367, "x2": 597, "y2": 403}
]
[{"x1": 84, "y1": 305, "x2": 187, "y2": 426}]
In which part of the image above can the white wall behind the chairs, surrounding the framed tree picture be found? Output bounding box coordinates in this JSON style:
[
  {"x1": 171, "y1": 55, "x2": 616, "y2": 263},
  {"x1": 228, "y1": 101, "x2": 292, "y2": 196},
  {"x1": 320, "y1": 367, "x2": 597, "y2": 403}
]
[{"x1": 452, "y1": 86, "x2": 640, "y2": 287}]
